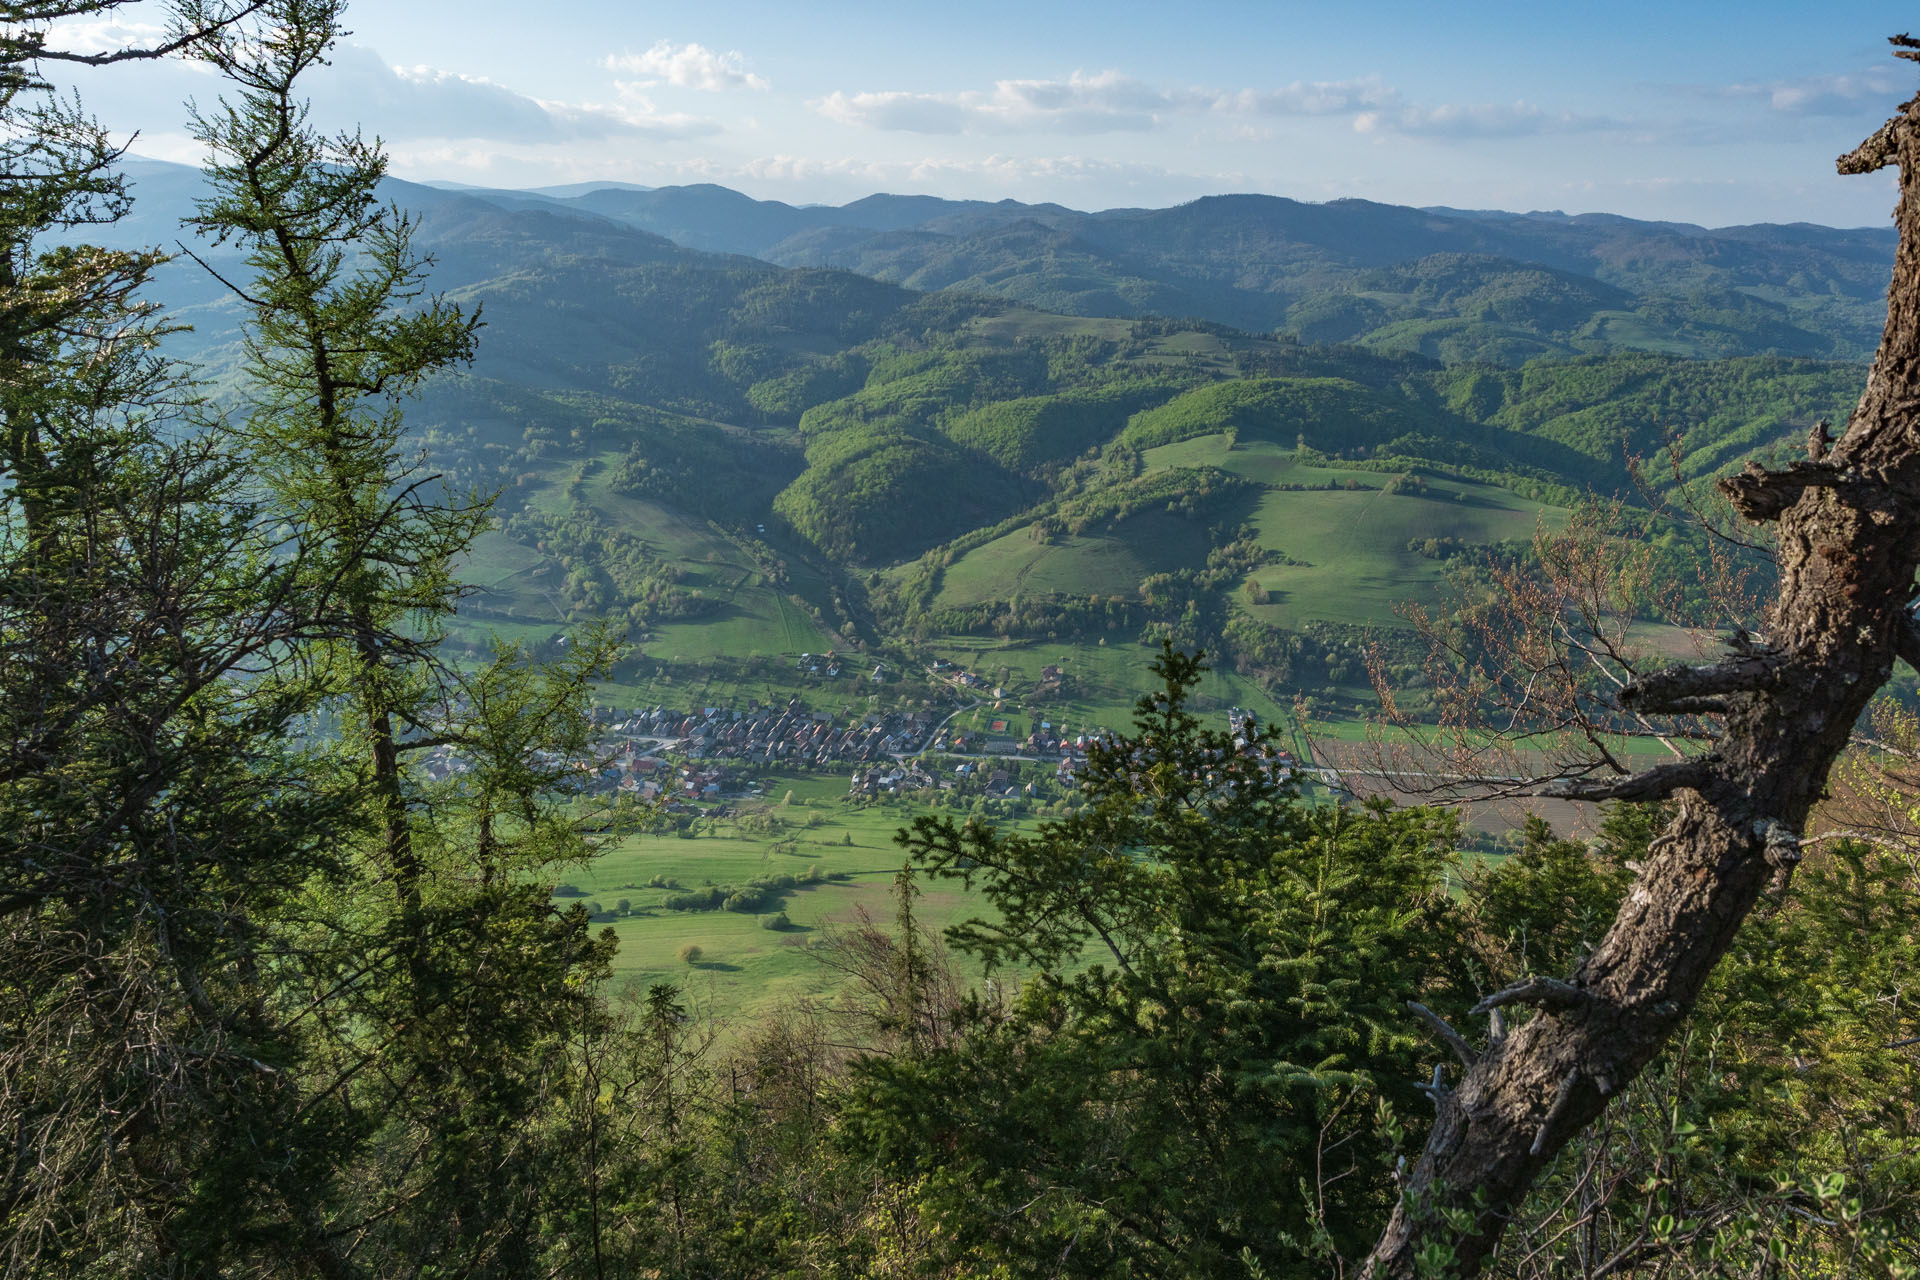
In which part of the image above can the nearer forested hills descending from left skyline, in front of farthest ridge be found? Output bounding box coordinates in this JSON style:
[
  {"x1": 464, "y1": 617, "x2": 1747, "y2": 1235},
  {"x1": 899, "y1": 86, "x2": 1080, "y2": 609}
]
[{"x1": 101, "y1": 155, "x2": 1866, "y2": 689}]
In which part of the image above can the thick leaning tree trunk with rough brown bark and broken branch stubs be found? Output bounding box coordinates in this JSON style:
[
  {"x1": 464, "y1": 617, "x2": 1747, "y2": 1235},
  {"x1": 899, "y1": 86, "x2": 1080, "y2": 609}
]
[{"x1": 1363, "y1": 36, "x2": 1920, "y2": 1280}]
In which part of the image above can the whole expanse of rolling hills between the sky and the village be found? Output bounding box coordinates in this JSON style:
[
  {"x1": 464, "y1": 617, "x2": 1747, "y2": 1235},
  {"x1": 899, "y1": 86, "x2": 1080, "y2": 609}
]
[{"x1": 93, "y1": 155, "x2": 1889, "y2": 717}]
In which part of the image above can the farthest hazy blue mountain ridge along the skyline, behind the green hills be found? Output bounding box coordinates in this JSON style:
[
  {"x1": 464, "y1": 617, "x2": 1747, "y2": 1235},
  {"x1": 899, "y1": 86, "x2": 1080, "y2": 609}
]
[{"x1": 428, "y1": 169, "x2": 1895, "y2": 363}]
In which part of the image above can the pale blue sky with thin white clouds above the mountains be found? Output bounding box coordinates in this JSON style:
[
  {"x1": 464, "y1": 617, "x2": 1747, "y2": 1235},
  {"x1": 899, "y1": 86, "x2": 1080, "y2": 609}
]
[{"x1": 41, "y1": 0, "x2": 1920, "y2": 226}]
